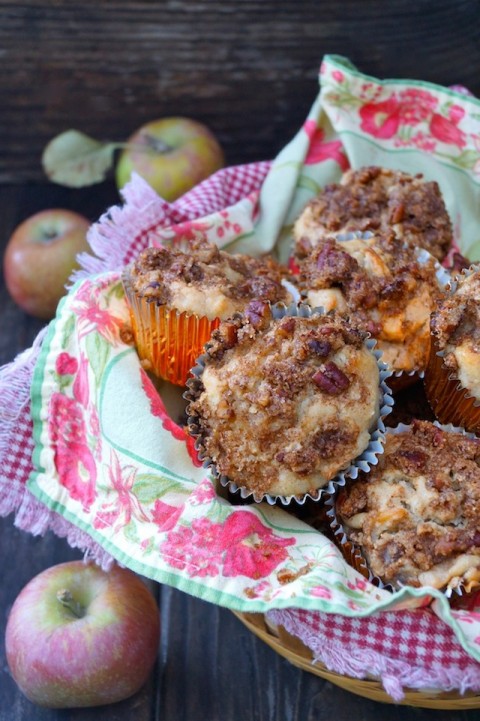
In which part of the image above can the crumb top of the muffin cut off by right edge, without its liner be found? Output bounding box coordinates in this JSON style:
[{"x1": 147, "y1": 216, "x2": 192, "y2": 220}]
[{"x1": 431, "y1": 269, "x2": 480, "y2": 400}]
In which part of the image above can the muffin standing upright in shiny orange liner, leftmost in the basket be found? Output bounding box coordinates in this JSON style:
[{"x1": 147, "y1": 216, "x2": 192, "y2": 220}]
[{"x1": 123, "y1": 238, "x2": 292, "y2": 385}]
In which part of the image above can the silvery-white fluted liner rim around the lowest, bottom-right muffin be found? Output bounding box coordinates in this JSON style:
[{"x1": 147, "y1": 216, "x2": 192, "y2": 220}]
[{"x1": 325, "y1": 421, "x2": 477, "y2": 598}]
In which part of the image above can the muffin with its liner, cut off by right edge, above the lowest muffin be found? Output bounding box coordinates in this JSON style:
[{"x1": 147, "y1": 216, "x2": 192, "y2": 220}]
[{"x1": 425, "y1": 265, "x2": 480, "y2": 433}]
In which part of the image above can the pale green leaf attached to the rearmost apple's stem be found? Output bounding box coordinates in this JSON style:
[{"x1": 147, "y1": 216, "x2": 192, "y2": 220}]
[{"x1": 42, "y1": 130, "x2": 119, "y2": 188}]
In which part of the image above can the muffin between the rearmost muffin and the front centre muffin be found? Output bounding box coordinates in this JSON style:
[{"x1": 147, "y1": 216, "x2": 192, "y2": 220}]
[{"x1": 298, "y1": 231, "x2": 446, "y2": 385}]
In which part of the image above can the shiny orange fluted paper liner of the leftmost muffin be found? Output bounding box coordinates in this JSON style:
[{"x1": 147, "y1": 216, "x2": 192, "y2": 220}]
[{"x1": 122, "y1": 270, "x2": 220, "y2": 386}]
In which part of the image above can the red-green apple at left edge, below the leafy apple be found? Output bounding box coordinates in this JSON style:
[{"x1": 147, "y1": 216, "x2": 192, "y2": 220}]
[{"x1": 3, "y1": 208, "x2": 91, "y2": 320}]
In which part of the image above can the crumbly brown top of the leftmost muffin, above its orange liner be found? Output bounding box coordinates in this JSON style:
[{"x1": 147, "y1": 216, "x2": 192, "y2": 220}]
[{"x1": 129, "y1": 239, "x2": 292, "y2": 320}]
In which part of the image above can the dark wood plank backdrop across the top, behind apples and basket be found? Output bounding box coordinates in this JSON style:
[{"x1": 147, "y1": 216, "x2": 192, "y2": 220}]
[{"x1": 0, "y1": 0, "x2": 480, "y2": 182}]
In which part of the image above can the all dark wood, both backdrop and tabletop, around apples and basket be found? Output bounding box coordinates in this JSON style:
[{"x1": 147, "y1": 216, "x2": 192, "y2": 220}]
[{"x1": 0, "y1": 0, "x2": 480, "y2": 721}]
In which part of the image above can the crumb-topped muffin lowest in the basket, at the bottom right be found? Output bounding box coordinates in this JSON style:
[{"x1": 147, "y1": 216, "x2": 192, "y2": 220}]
[{"x1": 335, "y1": 420, "x2": 480, "y2": 591}]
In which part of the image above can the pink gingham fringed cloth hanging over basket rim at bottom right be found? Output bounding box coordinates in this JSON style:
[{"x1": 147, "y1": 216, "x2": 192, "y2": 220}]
[{"x1": 267, "y1": 608, "x2": 480, "y2": 701}]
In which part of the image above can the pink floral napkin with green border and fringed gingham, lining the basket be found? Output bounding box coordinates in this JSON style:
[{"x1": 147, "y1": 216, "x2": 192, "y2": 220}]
[{"x1": 0, "y1": 56, "x2": 480, "y2": 697}]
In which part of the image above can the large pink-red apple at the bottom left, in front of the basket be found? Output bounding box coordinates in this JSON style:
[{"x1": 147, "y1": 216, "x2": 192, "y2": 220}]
[{"x1": 5, "y1": 561, "x2": 160, "y2": 708}]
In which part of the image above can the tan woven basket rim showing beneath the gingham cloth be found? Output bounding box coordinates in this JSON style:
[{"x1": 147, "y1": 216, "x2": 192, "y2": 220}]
[{"x1": 234, "y1": 612, "x2": 480, "y2": 710}]
